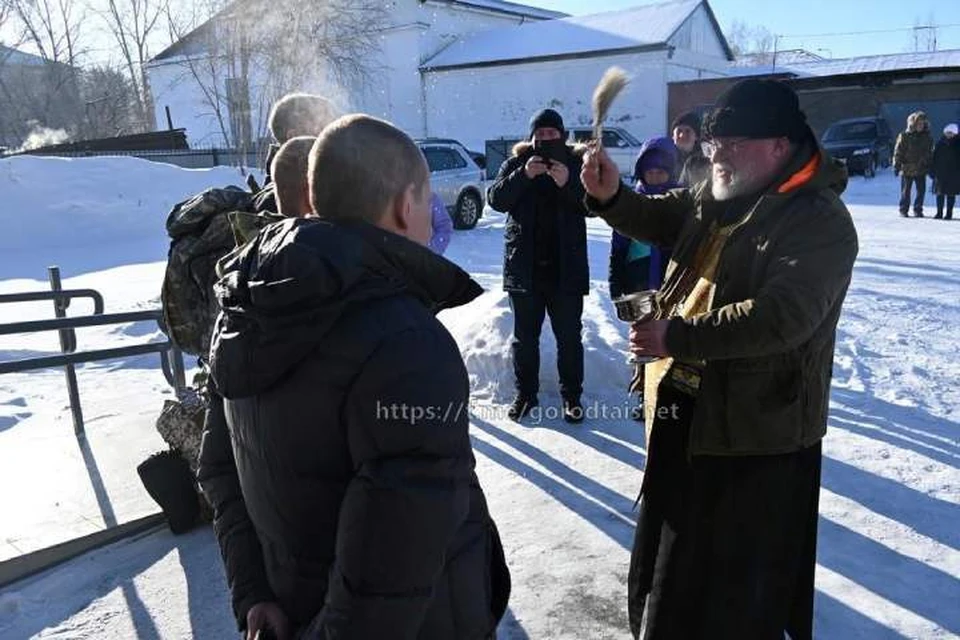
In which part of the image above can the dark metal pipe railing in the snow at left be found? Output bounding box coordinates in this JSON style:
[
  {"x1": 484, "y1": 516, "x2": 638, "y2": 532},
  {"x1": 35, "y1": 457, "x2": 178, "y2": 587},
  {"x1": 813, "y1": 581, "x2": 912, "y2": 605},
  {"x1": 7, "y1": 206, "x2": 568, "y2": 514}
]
[{"x1": 0, "y1": 267, "x2": 186, "y2": 436}]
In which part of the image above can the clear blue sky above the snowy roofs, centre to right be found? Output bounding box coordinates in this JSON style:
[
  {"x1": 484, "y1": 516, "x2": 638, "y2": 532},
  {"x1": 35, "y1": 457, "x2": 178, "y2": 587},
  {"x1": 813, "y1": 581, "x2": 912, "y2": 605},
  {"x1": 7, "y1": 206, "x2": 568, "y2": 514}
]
[{"x1": 517, "y1": 0, "x2": 960, "y2": 58}]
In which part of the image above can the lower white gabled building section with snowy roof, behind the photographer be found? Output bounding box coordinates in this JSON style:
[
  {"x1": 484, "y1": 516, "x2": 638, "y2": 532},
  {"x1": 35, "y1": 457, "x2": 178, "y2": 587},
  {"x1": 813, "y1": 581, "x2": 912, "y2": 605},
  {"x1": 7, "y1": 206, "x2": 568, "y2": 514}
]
[{"x1": 421, "y1": 0, "x2": 733, "y2": 148}]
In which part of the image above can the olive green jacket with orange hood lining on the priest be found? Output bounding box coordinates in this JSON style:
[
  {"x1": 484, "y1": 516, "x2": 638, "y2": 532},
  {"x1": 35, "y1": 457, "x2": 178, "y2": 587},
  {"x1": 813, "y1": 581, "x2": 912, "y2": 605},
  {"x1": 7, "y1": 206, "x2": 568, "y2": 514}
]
[{"x1": 587, "y1": 140, "x2": 858, "y2": 455}]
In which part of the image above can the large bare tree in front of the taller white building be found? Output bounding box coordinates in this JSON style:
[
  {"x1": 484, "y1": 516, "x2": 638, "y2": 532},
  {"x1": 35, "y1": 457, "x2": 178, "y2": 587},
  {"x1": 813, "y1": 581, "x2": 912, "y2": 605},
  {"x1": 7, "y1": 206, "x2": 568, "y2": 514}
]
[{"x1": 163, "y1": 0, "x2": 389, "y2": 146}]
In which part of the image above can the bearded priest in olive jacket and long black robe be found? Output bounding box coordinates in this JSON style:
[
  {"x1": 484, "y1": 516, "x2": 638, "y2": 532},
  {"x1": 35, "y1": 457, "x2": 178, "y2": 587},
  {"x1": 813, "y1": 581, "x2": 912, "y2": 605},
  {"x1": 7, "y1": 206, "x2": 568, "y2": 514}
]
[{"x1": 583, "y1": 79, "x2": 857, "y2": 640}]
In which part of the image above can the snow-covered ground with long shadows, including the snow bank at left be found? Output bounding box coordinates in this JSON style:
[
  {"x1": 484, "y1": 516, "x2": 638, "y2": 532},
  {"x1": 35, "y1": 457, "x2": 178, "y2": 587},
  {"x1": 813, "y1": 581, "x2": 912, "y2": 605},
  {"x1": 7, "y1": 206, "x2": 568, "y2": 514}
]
[{"x1": 0, "y1": 158, "x2": 960, "y2": 640}]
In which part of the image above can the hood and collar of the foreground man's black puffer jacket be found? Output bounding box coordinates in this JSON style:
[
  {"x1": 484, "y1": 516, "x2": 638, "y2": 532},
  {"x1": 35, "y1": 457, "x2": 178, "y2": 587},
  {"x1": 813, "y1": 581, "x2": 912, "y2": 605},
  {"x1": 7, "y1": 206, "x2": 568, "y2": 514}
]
[{"x1": 210, "y1": 218, "x2": 483, "y2": 398}]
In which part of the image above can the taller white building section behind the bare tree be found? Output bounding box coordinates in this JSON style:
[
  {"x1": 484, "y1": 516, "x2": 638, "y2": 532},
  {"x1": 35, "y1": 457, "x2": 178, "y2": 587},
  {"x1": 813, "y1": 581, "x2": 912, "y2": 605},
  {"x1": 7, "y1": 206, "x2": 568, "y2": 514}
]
[{"x1": 147, "y1": 0, "x2": 566, "y2": 146}]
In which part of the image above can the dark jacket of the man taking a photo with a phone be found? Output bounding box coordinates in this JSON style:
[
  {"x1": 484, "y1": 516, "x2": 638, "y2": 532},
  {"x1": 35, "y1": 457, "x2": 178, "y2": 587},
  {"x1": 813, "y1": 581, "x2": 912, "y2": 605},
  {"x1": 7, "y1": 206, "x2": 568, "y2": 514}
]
[{"x1": 487, "y1": 142, "x2": 590, "y2": 295}]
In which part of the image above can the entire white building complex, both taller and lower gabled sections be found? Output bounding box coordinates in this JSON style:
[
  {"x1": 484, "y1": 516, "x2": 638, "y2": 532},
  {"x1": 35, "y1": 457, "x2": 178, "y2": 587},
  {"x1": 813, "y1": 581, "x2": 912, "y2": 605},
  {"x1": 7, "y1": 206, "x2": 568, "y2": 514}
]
[{"x1": 142, "y1": 0, "x2": 733, "y2": 149}]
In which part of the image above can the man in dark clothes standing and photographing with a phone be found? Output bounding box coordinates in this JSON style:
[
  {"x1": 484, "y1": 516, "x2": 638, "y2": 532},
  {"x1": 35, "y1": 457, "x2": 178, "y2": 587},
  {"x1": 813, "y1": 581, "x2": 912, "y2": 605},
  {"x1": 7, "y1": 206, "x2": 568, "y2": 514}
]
[{"x1": 487, "y1": 109, "x2": 590, "y2": 422}]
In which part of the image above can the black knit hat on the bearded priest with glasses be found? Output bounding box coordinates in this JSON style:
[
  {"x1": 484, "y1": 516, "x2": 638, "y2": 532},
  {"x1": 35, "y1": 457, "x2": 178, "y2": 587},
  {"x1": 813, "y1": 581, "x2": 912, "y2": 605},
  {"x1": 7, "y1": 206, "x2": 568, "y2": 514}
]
[{"x1": 703, "y1": 78, "x2": 810, "y2": 142}]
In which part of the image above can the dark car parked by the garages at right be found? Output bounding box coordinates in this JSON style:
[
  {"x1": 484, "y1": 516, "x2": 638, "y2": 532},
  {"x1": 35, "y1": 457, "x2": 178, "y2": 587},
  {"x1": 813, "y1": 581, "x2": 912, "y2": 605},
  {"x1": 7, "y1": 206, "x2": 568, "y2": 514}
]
[{"x1": 822, "y1": 117, "x2": 893, "y2": 178}]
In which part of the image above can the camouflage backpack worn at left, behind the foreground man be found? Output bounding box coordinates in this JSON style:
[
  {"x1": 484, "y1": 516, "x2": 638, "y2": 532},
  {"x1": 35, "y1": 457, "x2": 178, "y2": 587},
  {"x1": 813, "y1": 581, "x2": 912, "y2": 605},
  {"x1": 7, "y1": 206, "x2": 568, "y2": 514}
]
[{"x1": 160, "y1": 186, "x2": 280, "y2": 358}]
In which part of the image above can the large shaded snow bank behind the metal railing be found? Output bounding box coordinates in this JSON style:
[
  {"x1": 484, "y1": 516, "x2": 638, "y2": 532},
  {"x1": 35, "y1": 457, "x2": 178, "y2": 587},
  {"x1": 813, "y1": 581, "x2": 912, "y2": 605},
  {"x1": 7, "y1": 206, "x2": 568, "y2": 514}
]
[{"x1": 0, "y1": 156, "x2": 251, "y2": 278}]
